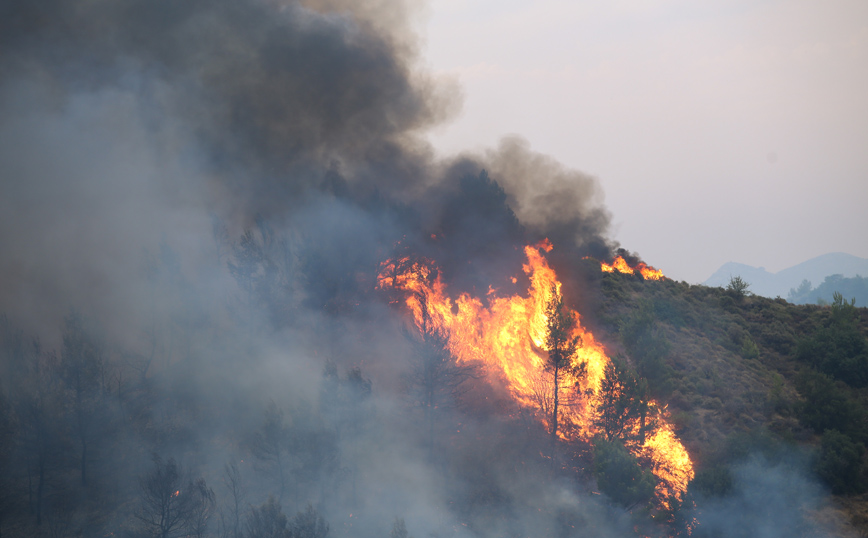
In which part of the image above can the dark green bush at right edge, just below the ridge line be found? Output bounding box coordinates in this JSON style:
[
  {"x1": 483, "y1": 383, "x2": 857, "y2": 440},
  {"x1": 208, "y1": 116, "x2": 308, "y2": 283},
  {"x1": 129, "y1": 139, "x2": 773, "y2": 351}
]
[{"x1": 796, "y1": 293, "x2": 868, "y2": 387}]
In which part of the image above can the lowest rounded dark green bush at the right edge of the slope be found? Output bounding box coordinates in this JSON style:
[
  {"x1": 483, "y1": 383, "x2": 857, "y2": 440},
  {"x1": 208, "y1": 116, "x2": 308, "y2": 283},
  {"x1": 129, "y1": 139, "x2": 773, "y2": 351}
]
[{"x1": 815, "y1": 430, "x2": 868, "y2": 495}]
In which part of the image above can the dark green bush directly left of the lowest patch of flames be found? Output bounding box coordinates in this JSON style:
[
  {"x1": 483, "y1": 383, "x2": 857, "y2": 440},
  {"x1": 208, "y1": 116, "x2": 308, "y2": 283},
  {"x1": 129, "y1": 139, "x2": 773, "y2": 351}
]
[{"x1": 594, "y1": 436, "x2": 655, "y2": 507}]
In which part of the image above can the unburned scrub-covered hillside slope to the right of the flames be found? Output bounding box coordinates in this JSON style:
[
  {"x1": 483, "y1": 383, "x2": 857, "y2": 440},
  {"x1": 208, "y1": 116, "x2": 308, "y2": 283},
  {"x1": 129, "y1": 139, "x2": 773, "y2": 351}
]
[{"x1": 596, "y1": 274, "x2": 868, "y2": 533}]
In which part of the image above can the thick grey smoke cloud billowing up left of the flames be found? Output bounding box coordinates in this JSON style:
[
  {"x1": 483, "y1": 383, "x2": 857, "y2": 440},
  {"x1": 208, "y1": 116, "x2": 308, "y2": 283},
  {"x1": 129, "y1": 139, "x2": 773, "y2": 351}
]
[{"x1": 0, "y1": 0, "x2": 700, "y2": 536}]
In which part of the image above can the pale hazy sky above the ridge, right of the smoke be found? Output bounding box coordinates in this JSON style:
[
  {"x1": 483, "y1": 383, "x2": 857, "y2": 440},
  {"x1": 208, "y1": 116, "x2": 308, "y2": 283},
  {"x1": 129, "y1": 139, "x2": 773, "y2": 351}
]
[{"x1": 423, "y1": 0, "x2": 868, "y2": 282}]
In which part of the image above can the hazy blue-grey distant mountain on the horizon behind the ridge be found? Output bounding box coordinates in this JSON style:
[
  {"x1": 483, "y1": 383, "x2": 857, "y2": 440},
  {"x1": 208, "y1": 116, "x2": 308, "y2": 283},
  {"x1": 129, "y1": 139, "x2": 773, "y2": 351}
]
[{"x1": 703, "y1": 252, "x2": 868, "y2": 298}]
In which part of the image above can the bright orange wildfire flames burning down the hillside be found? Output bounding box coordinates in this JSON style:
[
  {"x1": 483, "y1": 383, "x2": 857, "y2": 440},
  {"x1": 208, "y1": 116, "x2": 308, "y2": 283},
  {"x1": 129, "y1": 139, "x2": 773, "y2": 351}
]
[{"x1": 377, "y1": 240, "x2": 693, "y2": 503}]
